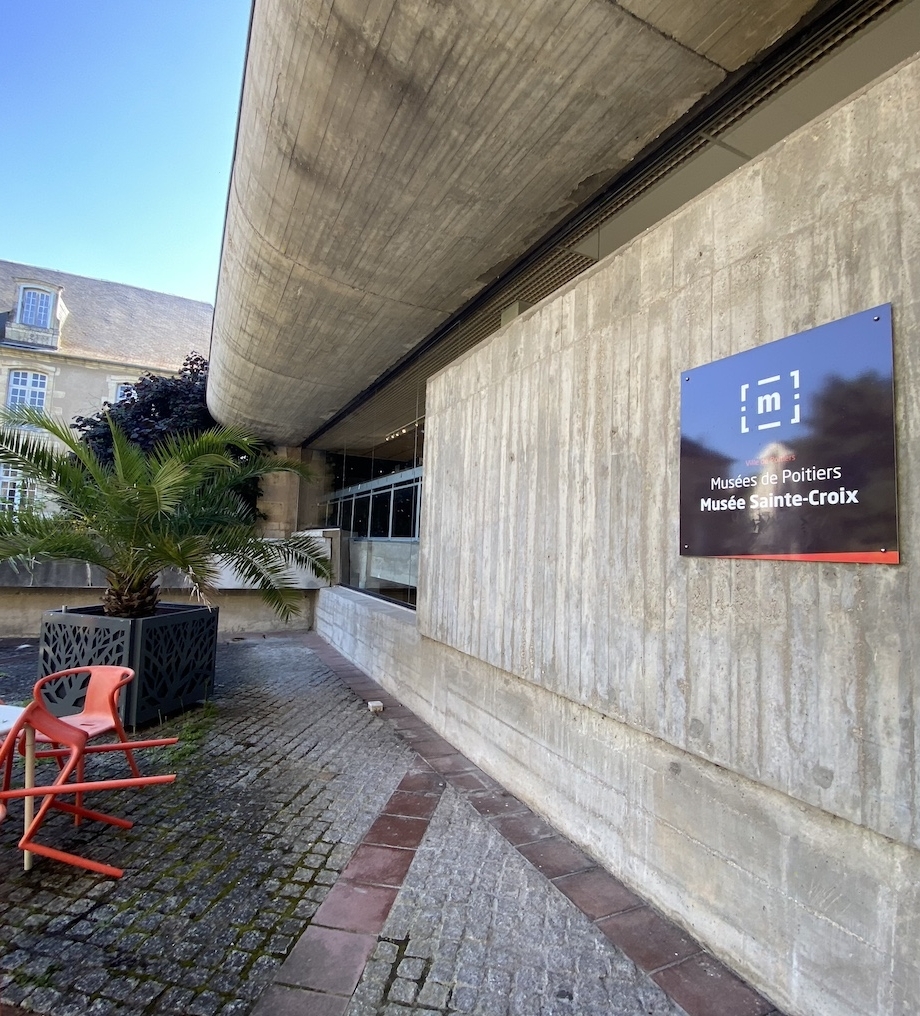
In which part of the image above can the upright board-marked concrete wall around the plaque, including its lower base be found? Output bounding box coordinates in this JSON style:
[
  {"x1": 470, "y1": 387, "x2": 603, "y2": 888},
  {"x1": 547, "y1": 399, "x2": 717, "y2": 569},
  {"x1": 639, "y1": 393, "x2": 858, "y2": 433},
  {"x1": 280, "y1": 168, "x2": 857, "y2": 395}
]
[{"x1": 317, "y1": 53, "x2": 920, "y2": 1016}]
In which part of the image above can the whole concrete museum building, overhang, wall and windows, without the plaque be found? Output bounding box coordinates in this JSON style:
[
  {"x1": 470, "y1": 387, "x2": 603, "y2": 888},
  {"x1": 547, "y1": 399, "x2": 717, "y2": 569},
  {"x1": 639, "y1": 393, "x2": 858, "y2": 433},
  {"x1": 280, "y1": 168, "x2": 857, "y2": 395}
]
[{"x1": 208, "y1": 0, "x2": 920, "y2": 1016}]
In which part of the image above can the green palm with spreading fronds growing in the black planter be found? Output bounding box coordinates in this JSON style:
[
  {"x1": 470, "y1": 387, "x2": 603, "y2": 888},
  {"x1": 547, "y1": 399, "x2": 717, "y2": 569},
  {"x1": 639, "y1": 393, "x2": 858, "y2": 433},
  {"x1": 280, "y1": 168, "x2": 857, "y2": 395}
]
[{"x1": 0, "y1": 406, "x2": 330, "y2": 620}]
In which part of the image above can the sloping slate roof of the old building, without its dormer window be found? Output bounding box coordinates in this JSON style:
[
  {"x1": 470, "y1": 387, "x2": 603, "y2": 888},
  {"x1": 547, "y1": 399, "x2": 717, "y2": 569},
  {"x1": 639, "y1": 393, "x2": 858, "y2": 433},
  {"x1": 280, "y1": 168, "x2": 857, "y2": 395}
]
[{"x1": 0, "y1": 261, "x2": 213, "y2": 370}]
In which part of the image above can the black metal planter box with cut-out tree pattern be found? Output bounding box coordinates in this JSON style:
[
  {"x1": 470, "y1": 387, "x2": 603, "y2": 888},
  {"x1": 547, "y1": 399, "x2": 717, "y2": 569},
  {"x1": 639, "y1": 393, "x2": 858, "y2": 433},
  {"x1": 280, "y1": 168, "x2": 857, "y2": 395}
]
[{"x1": 39, "y1": 604, "x2": 217, "y2": 726}]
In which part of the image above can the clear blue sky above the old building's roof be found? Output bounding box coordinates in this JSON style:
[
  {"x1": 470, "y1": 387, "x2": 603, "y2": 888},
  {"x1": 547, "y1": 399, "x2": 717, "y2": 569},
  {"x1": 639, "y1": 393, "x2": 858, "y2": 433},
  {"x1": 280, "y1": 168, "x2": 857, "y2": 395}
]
[{"x1": 0, "y1": 0, "x2": 250, "y2": 303}]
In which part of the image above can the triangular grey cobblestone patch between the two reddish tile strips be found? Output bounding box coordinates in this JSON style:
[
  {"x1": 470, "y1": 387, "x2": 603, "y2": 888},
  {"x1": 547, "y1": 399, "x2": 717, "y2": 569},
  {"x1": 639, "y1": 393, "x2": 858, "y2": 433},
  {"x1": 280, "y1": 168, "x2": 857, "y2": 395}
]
[{"x1": 346, "y1": 787, "x2": 682, "y2": 1016}]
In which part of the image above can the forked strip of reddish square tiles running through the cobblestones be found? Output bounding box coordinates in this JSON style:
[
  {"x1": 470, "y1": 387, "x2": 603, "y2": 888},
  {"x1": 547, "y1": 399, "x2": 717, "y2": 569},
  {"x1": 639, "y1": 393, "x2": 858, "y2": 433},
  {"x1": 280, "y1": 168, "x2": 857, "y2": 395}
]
[{"x1": 255, "y1": 635, "x2": 783, "y2": 1016}]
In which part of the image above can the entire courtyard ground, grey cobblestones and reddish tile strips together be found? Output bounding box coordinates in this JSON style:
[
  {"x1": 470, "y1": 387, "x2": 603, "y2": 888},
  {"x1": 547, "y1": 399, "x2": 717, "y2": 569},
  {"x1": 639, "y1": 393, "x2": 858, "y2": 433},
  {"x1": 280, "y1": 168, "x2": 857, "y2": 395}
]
[{"x1": 0, "y1": 634, "x2": 779, "y2": 1016}]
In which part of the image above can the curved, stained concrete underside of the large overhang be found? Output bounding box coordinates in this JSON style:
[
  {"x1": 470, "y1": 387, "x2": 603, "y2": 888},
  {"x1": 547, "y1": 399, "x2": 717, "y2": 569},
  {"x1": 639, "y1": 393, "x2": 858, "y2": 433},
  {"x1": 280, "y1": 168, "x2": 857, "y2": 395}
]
[{"x1": 208, "y1": 0, "x2": 814, "y2": 444}]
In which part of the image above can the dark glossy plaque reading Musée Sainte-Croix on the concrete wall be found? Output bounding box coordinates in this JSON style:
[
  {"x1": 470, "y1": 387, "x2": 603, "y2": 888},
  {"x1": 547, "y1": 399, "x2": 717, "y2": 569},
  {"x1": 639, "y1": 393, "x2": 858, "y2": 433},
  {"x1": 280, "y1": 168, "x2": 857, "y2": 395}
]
[{"x1": 680, "y1": 304, "x2": 899, "y2": 564}]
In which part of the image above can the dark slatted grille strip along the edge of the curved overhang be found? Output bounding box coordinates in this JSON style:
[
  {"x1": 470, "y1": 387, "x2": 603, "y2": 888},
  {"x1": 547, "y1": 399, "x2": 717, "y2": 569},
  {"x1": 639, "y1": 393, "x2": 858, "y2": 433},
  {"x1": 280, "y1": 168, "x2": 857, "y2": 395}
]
[{"x1": 305, "y1": 0, "x2": 903, "y2": 455}]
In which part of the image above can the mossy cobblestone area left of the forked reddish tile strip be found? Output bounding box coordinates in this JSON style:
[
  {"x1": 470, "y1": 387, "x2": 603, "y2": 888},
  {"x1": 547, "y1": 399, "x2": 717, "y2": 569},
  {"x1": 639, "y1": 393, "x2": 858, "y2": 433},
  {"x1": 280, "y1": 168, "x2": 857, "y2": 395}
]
[{"x1": 0, "y1": 639, "x2": 412, "y2": 1016}]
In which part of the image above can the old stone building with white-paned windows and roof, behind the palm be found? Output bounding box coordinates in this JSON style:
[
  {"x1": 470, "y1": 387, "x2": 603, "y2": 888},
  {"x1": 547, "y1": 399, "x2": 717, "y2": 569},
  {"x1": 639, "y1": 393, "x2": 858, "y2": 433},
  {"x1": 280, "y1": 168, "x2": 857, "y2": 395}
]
[{"x1": 0, "y1": 261, "x2": 212, "y2": 504}]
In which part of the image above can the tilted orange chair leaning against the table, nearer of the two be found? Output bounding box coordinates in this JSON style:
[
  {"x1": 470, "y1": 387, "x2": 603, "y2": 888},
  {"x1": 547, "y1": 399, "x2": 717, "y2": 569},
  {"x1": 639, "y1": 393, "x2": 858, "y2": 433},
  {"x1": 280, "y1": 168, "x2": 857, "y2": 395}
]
[{"x1": 0, "y1": 701, "x2": 179, "y2": 878}]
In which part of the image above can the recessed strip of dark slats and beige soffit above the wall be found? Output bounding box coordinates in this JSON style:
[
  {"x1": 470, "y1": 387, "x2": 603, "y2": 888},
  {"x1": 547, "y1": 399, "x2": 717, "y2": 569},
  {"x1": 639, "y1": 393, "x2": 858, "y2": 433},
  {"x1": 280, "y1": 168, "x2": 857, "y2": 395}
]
[{"x1": 308, "y1": 0, "x2": 920, "y2": 461}]
